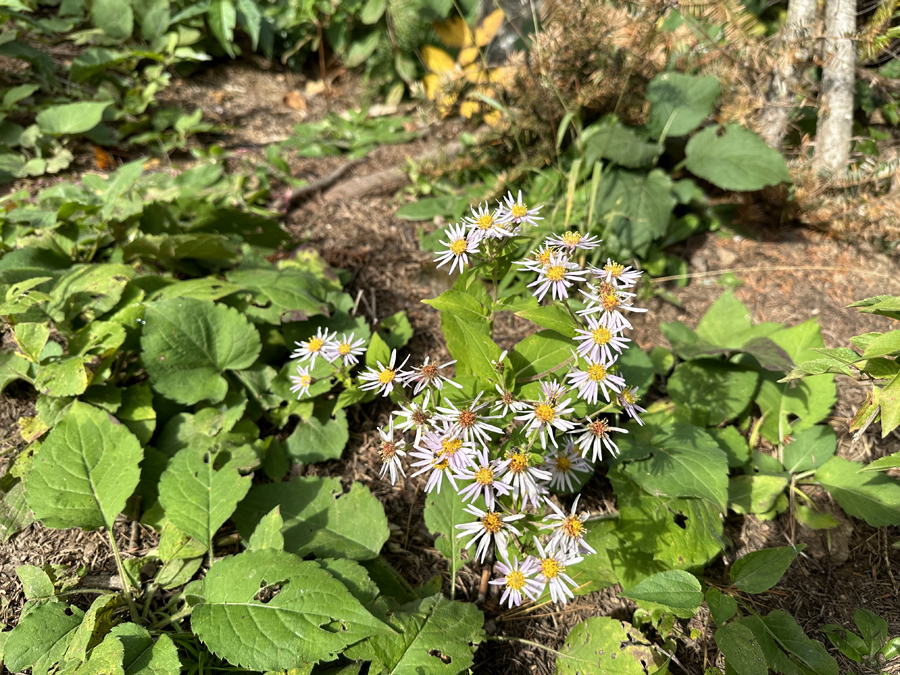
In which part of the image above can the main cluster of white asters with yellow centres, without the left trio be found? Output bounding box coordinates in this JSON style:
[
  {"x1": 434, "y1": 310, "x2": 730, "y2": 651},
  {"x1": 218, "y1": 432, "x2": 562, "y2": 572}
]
[{"x1": 368, "y1": 192, "x2": 645, "y2": 607}]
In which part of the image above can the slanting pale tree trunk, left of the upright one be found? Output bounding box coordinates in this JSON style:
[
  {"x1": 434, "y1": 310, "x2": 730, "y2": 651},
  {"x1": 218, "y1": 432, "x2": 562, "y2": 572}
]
[{"x1": 759, "y1": 0, "x2": 818, "y2": 150}]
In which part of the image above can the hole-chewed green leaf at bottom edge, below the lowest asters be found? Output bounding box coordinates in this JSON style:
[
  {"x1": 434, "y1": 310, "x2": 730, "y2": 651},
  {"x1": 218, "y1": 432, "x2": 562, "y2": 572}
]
[{"x1": 370, "y1": 594, "x2": 484, "y2": 675}]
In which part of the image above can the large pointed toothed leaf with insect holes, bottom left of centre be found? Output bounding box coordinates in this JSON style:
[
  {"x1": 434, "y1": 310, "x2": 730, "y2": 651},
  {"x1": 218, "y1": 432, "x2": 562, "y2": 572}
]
[{"x1": 191, "y1": 550, "x2": 393, "y2": 671}]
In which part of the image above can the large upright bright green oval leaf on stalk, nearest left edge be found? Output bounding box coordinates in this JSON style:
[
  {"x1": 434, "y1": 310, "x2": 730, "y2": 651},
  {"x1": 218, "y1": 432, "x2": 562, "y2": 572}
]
[{"x1": 25, "y1": 401, "x2": 143, "y2": 530}]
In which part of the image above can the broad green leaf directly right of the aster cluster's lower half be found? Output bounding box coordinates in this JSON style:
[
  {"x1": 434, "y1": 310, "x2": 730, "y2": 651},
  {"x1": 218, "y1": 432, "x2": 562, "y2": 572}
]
[{"x1": 620, "y1": 424, "x2": 728, "y2": 512}]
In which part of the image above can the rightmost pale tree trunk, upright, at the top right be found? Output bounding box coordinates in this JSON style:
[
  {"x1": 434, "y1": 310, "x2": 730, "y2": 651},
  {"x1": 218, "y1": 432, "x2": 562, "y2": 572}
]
[{"x1": 814, "y1": 0, "x2": 856, "y2": 173}]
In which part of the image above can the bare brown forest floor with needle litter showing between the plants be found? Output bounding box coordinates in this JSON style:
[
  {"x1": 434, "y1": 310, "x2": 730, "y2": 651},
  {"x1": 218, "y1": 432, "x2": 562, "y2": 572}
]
[{"x1": 0, "y1": 64, "x2": 900, "y2": 675}]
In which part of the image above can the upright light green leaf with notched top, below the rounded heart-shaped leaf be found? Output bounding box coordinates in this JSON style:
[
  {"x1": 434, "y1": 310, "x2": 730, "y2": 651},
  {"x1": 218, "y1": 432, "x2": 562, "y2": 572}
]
[{"x1": 159, "y1": 447, "x2": 252, "y2": 545}]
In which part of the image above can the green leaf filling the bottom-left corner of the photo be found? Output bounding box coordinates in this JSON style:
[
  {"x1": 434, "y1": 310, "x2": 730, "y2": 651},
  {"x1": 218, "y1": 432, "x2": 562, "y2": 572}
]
[{"x1": 3, "y1": 602, "x2": 84, "y2": 673}]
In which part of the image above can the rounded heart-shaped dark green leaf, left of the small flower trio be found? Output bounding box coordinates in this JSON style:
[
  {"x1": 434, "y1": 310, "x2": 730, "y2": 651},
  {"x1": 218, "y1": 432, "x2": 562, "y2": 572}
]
[{"x1": 141, "y1": 298, "x2": 261, "y2": 405}]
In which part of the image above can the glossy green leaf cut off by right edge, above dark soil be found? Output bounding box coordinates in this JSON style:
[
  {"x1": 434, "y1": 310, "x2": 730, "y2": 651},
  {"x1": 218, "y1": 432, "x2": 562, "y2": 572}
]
[{"x1": 815, "y1": 457, "x2": 900, "y2": 527}]
